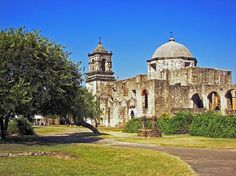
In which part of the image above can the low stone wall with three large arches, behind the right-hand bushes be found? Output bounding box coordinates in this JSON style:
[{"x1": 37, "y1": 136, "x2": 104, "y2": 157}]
[{"x1": 169, "y1": 85, "x2": 235, "y2": 114}]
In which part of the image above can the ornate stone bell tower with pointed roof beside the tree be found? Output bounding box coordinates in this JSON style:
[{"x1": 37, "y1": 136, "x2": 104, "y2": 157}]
[{"x1": 86, "y1": 38, "x2": 115, "y2": 94}]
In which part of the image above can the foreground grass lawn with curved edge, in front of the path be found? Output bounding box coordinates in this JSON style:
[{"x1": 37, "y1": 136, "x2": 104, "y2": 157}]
[{"x1": 0, "y1": 144, "x2": 193, "y2": 176}]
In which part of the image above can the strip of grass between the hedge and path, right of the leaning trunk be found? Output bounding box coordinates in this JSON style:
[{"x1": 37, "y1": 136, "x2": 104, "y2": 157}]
[{"x1": 97, "y1": 128, "x2": 236, "y2": 149}]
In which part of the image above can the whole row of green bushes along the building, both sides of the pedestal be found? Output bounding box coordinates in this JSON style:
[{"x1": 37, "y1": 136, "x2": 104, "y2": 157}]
[{"x1": 123, "y1": 112, "x2": 236, "y2": 138}]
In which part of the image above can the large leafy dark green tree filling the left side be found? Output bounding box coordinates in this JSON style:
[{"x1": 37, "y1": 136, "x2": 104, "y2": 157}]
[{"x1": 0, "y1": 28, "x2": 100, "y2": 139}]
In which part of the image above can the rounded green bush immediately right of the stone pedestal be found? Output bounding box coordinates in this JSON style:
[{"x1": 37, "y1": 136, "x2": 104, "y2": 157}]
[{"x1": 157, "y1": 112, "x2": 193, "y2": 134}]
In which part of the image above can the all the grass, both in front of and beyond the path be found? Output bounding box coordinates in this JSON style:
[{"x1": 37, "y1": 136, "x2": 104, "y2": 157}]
[{"x1": 0, "y1": 126, "x2": 236, "y2": 176}]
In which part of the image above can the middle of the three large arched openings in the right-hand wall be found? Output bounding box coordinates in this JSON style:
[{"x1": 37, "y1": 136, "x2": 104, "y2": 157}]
[{"x1": 207, "y1": 92, "x2": 221, "y2": 111}]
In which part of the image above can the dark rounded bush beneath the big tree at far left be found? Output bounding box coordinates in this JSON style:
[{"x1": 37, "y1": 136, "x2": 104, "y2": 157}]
[{"x1": 7, "y1": 117, "x2": 34, "y2": 135}]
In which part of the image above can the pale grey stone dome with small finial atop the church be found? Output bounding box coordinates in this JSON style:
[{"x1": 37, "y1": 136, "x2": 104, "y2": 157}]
[{"x1": 152, "y1": 37, "x2": 192, "y2": 58}]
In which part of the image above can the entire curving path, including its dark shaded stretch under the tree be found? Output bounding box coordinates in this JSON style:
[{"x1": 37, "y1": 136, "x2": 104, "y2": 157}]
[{"x1": 35, "y1": 131, "x2": 236, "y2": 176}]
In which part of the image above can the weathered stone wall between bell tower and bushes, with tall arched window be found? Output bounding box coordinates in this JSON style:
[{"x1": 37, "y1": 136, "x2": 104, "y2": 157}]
[{"x1": 97, "y1": 75, "x2": 159, "y2": 126}]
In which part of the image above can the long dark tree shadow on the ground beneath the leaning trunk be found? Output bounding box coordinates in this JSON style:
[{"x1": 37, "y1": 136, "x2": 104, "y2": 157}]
[{"x1": 0, "y1": 132, "x2": 108, "y2": 145}]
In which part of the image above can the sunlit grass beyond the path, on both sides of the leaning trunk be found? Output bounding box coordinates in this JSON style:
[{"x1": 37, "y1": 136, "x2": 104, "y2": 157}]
[{"x1": 34, "y1": 125, "x2": 236, "y2": 149}]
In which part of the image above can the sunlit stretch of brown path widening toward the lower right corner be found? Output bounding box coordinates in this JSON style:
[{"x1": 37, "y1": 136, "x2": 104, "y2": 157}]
[{"x1": 103, "y1": 141, "x2": 236, "y2": 176}]
